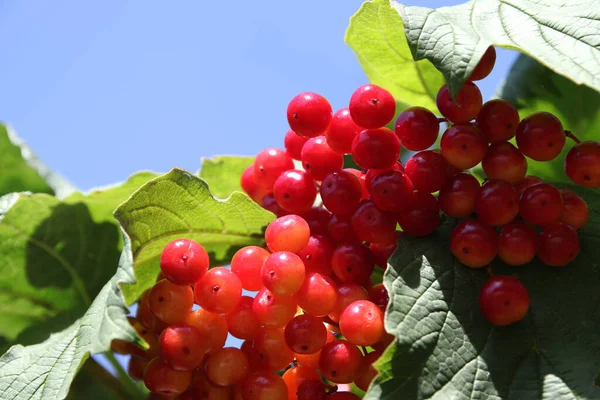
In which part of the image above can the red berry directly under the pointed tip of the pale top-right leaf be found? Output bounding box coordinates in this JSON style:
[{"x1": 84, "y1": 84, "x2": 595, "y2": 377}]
[{"x1": 435, "y1": 81, "x2": 483, "y2": 124}]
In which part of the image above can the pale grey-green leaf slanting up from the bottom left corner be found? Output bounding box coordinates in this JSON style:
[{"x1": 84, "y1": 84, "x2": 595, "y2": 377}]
[{"x1": 0, "y1": 234, "x2": 142, "y2": 400}]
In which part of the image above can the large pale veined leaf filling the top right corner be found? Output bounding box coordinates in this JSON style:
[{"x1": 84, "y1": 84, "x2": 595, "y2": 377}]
[{"x1": 392, "y1": 0, "x2": 600, "y2": 95}]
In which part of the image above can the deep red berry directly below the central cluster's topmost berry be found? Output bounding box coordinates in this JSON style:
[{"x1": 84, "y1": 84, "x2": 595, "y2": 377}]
[{"x1": 352, "y1": 128, "x2": 400, "y2": 169}]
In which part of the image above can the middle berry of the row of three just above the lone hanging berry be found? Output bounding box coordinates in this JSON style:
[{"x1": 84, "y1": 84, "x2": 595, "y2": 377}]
[{"x1": 498, "y1": 221, "x2": 537, "y2": 265}]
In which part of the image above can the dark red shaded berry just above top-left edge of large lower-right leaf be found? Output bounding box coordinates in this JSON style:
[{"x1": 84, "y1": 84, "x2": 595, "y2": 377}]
[{"x1": 398, "y1": 190, "x2": 440, "y2": 237}]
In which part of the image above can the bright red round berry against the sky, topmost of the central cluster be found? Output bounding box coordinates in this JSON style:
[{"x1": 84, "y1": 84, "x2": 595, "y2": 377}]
[{"x1": 349, "y1": 84, "x2": 396, "y2": 129}]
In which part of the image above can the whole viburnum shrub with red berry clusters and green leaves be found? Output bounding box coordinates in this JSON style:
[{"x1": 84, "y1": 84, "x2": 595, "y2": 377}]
[{"x1": 0, "y1": 0, "x2": 600, "y2": 400}]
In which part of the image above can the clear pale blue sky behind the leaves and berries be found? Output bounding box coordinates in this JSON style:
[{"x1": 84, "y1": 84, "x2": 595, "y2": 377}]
[{"x1": 0, "y1": 0, "x2": 514, "y2": 189}]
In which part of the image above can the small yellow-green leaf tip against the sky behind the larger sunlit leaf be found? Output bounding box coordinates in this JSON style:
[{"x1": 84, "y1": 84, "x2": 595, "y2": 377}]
[{"x1": 199, "y1": 156, "x2": 254, "y2": 199}]
